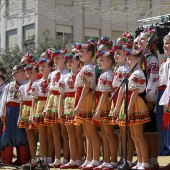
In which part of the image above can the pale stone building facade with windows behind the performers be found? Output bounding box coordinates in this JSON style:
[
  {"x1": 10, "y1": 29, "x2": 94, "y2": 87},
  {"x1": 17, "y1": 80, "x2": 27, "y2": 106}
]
[{"x1": 0, "y1": 0, "x2": 170, "y2": 49}]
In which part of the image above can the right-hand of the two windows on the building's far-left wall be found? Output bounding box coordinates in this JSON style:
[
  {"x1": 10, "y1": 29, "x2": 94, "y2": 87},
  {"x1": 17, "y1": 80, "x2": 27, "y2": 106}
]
[{"x1": 23, "y1": 24, "x2": 35, "y2": 41}]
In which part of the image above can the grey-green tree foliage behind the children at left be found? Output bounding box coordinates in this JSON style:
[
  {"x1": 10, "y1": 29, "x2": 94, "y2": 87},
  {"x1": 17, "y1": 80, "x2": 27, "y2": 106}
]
[{"x1": 0, "y1": 30, "x2": 67, "y2": 76}]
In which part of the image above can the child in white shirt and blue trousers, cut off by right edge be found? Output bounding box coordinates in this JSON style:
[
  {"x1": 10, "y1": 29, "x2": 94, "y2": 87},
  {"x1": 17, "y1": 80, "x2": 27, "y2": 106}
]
[{"x1": 156, "y1": 35, "x2": 170, "y2": 155}]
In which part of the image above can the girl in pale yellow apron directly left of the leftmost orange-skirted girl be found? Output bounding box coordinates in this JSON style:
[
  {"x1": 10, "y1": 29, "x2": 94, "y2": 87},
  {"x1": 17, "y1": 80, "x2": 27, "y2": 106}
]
[{"x1": 58, "y1": 49, "x2": 83, "y2": 169}]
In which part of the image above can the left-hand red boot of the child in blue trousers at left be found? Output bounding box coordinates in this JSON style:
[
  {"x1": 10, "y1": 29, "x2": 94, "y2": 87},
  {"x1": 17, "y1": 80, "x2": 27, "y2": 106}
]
[{"x1": 2, "y1": 147, "x2": 13, "y2": 165}]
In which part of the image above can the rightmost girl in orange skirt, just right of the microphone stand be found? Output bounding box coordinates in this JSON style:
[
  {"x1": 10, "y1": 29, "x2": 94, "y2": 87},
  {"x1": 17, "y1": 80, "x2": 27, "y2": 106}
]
[{"x1": 124, "y1": 49, "x2": 150, "y2": 170}]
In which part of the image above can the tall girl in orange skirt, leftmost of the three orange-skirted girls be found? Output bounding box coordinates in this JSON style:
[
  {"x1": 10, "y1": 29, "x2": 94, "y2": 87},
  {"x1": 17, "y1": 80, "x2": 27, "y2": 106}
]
[{"x1": 74, "y1": 39, "x2": 101, "y2": 169}]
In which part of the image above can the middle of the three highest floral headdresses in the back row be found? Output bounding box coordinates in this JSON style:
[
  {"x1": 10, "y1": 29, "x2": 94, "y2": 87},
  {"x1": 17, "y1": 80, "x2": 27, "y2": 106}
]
[{"x1": 122, "y1": 32, "x2": 134, "y2": 48}]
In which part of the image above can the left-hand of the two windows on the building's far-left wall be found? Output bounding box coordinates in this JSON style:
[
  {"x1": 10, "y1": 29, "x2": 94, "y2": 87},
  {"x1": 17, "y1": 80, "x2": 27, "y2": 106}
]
[{"x1": 6, "y1": 29, "x2": 18, "y2": 49}]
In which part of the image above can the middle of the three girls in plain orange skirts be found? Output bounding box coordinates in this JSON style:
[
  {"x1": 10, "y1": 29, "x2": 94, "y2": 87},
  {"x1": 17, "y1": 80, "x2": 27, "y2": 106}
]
[{"x1": 93, "y1": 51, "x2": 118, "y2": 170}]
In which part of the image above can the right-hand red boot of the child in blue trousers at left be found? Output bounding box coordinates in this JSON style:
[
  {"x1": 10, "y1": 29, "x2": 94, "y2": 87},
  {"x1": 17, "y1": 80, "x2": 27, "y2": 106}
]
[{"x1": 18, "y1": 146, "x2": 31, "y2": 165}]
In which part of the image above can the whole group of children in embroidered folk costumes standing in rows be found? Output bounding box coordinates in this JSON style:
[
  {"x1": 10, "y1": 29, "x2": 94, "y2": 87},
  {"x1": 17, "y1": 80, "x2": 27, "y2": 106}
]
[{"x1": 0, "y1": 26, "x2": 170, "y2": 170}]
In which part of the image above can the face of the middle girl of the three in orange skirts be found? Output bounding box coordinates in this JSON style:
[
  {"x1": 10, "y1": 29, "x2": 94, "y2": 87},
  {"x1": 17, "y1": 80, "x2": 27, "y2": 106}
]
[{"x1": 98, "y1": 56, "x2": 111, "y2": 71}]
